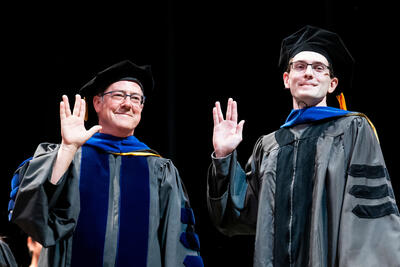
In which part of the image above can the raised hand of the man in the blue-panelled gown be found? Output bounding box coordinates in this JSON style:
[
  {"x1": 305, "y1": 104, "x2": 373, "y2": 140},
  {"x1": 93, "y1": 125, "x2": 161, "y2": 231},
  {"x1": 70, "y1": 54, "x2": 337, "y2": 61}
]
[{"x1": 60, "y1": 95, "x2": 101, "y2": 150}]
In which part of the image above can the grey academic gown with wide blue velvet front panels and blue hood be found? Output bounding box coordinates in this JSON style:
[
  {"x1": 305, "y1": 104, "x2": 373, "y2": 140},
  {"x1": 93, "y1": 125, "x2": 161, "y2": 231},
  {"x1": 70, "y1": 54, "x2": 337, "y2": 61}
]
[{"x1": 10, "y1": 133, "x2": 202, "y2": 267}]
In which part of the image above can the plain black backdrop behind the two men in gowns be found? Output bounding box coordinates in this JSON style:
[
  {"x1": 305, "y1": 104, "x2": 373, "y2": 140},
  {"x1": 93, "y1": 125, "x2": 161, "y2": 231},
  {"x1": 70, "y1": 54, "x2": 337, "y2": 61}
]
[{"x1": 0, "y1": 0, "x2": 400, "y2": 267}]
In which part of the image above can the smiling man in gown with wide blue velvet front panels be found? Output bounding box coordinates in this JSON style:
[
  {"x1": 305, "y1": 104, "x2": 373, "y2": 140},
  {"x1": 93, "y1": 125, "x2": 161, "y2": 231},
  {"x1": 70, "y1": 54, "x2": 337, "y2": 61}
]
[{"x1": 9, "y1": 60, "x2": 203, "y2": 267}]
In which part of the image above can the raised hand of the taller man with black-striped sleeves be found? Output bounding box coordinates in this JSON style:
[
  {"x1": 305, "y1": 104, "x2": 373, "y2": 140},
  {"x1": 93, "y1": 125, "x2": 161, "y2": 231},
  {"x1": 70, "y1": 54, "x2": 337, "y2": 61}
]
[{"x1": 213, "y1": 98, "x2": 244, "y2": 158}]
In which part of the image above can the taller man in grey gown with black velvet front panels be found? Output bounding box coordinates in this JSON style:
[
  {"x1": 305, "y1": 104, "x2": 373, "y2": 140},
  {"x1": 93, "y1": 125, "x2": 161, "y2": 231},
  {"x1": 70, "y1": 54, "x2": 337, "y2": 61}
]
[{"x1": 207, "y1": 26, "x2": 400, "y2": 266}]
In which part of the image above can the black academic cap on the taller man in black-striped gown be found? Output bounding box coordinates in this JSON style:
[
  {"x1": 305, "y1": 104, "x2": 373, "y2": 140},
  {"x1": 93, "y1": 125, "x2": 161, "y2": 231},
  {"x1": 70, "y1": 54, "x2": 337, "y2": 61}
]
[{"x1": 279, "y1": 25, "x2": 354, "y2": 90}]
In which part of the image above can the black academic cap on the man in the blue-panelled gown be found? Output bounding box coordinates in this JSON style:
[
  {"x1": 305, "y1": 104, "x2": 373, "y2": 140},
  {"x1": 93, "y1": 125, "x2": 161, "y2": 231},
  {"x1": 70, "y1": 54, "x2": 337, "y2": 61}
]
[{"x1": 79, "y1": 60, "x2": 154, "y2": 97}]
